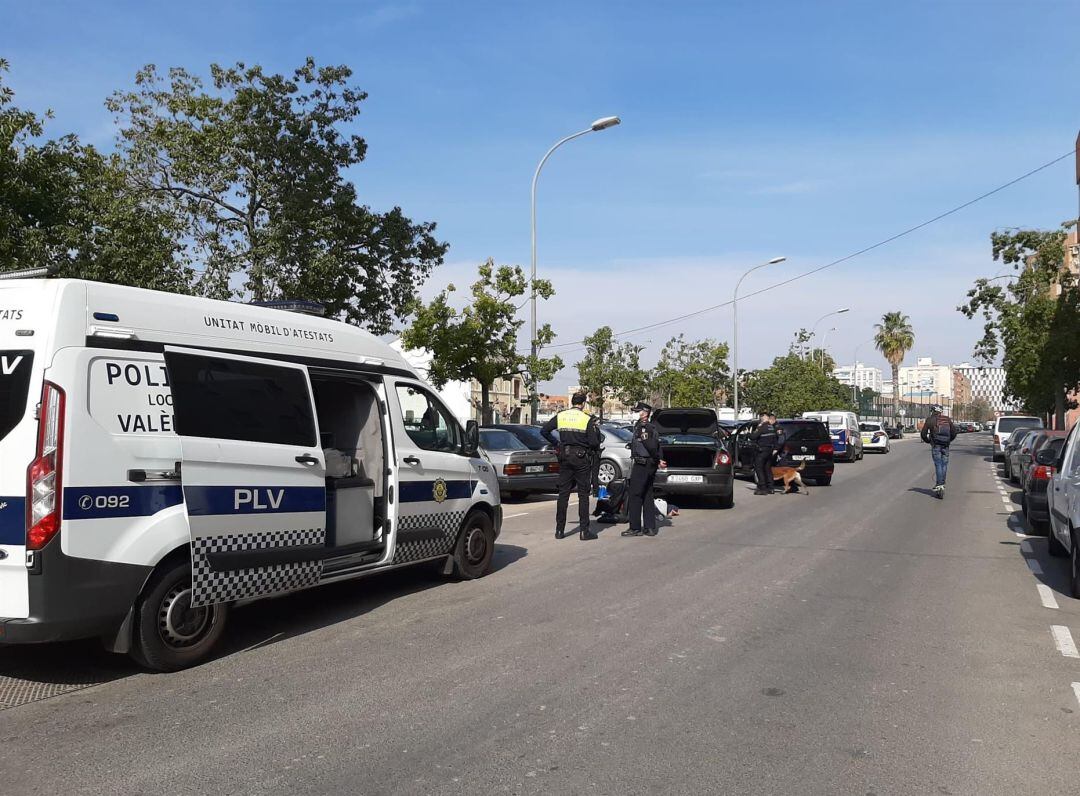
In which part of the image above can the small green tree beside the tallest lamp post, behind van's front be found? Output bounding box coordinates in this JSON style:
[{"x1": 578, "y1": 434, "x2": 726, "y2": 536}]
[{"x1": 402, "y1": 259, "x2": 563, "y2": 423}]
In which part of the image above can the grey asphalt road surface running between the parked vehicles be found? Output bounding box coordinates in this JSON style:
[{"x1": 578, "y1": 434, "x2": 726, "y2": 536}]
[{"x1": 0, "y1": 434, "x2": 1080, "y2": 795}]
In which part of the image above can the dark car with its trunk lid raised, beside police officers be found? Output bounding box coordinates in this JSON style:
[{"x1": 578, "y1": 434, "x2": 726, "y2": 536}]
[{"x1": 652, "y1": 408, "x2": 735, "y2": 509}]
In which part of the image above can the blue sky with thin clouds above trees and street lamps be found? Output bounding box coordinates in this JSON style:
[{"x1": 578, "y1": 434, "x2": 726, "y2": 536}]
[{"x1": 0, "y1": 0, "x2": 1080, "y2": 382}]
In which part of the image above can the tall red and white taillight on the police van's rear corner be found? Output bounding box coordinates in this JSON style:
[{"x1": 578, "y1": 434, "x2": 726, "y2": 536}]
[{"x1": 26, "y1": 381, "x2": 64, "y2": 550}]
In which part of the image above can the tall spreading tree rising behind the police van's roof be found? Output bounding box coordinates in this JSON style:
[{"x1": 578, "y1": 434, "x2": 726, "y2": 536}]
[{"x1": 107, "y1": 58, "x2": 446, "y2": 334}]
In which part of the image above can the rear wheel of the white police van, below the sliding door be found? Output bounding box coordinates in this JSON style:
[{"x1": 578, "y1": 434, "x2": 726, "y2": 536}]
[{"x1": 132, "y1": 561, "x2": 229, "y2": 672}]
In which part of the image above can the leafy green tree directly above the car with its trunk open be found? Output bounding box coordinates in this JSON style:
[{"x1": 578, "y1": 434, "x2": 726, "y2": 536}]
[{"x1": 649, "y1": 335, "x2": 731, "y2": 407}]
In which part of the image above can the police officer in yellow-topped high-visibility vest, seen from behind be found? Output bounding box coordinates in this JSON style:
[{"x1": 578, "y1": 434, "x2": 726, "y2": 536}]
[{"x1": 540, "y1": 392, "x2": 600, "y2": 539}]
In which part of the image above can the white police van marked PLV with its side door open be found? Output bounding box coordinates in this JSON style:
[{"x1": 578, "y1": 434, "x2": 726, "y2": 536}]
[{"x1": 0, "y1": 279, "x2": 502, "y2": 670}]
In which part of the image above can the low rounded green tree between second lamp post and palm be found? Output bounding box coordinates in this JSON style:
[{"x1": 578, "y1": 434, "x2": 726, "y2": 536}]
[{"x1": 743, "y1": 353, "x2": 854, "y2": 417}]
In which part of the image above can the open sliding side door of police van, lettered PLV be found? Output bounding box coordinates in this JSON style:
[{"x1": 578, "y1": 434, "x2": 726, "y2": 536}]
[{"x1": 165, "y1": 348, "x2": 326, "y2": 606}]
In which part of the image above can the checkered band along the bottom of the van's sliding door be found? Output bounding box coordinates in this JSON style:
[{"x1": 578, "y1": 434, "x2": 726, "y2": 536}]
[{"x1": 191, "y1": 528, "x2": 326, "y2": 607}]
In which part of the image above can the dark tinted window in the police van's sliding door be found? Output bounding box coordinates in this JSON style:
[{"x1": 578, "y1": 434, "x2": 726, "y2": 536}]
[{"x1": 166, "y1": 354, "x2": 316, "y2": 446}]
